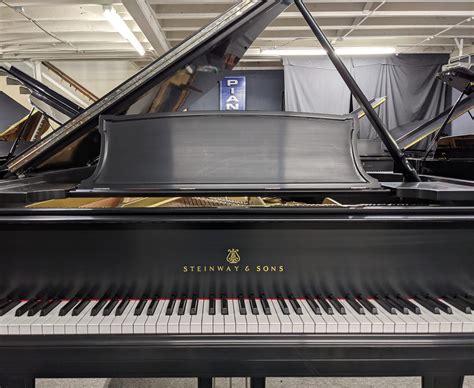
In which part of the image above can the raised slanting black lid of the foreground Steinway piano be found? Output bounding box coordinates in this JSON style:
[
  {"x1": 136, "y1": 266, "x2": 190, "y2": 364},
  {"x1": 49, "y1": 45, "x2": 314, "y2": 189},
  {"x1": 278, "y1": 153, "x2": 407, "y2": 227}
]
[{"x1": 6, "y1": 0, "x2": 291, "y2": 175}]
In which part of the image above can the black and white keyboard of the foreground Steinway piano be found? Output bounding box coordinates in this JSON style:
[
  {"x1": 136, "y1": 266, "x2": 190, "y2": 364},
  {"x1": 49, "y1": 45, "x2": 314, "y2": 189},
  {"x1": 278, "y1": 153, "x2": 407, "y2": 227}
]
[{"x1": 0, "y1": 296, "x2": 474, "y2": 335}]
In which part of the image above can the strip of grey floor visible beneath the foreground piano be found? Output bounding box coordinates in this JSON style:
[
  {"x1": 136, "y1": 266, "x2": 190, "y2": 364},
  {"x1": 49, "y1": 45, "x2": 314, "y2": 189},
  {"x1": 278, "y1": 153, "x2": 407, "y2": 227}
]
[{"x1": 36, "y1": 376, "x2": 474, "y2": 388}]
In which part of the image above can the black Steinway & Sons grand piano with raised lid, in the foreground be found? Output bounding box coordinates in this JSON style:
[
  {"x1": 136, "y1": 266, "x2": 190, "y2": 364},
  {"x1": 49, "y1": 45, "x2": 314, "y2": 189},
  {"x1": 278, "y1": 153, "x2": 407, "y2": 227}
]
[{"x1": 0, "y1": 0, "x2": 474, "y2": 388}]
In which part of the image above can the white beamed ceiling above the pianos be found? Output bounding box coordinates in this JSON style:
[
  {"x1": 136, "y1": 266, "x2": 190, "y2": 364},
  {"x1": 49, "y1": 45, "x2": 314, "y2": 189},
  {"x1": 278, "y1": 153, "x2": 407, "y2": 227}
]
[{"x1": 0, "y1": 0, "x2": 474, "y2": 66}]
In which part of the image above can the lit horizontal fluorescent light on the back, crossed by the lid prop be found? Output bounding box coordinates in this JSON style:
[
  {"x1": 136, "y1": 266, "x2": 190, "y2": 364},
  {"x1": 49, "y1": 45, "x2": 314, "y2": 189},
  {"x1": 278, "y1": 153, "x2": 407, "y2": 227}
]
[{"x1": 260, "y1": 47, "x2": 397, "y2": 57}]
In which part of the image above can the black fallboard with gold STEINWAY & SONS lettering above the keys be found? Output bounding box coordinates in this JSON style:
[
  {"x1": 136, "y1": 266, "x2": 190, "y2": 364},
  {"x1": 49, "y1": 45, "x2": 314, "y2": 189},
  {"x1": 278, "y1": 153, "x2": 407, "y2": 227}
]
[{"x1": 0, "y1": 207, "x2": 474, "y2": 298}]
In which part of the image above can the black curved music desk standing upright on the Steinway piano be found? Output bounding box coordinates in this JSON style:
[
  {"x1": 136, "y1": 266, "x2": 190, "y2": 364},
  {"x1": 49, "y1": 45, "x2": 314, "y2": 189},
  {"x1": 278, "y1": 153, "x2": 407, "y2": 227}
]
[{"x1": 75, "y1": 112, "x2": 380, "y2": 196}]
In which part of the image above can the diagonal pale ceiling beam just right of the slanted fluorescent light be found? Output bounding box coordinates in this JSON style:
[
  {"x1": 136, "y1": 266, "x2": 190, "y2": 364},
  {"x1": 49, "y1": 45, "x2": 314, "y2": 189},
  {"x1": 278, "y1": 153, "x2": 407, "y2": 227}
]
[{"x1": 123, "y1": 0, "x2": 171, "y2": 55}]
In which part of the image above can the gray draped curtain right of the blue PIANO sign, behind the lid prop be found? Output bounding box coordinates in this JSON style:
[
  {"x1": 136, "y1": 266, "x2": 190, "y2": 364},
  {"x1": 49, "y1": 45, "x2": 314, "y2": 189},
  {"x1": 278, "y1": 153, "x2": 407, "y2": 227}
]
[{"x1": 283, "y1": 54, "x2": 451, "y2": 139}]
